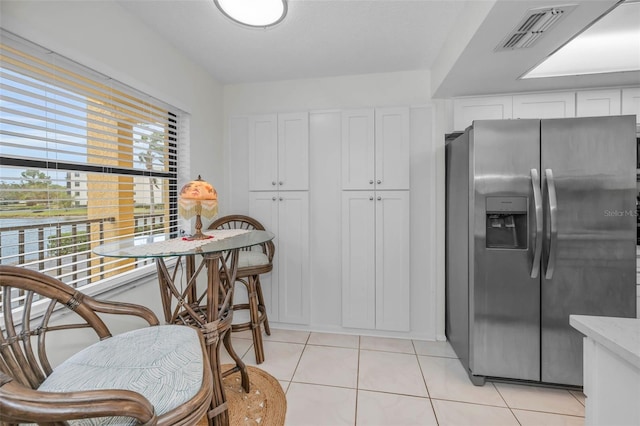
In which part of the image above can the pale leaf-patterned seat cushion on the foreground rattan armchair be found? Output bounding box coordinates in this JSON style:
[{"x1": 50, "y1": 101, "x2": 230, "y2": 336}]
[{"x1": 39, "y1": 325, "x2": 204, "y2": 425}]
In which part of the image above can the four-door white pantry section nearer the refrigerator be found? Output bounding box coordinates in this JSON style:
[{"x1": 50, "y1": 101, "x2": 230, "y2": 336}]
[{"x1": 342, "y1": 108, "x2": 411, "y2": 331}]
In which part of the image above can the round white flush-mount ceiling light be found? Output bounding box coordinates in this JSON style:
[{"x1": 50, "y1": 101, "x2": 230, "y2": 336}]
[{"x1": 213, "y1": 0, "x2": 287, "y2": 28}]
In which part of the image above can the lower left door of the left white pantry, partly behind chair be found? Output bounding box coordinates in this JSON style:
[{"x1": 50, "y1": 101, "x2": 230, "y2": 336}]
[{"x1": 249, "y1": 191, "x2": 281, "y2": 321}]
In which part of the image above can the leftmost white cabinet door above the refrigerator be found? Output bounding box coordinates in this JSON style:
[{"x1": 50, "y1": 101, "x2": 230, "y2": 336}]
[{"x1": 453, "y1": 96, "x2": 513, "y2": 131}]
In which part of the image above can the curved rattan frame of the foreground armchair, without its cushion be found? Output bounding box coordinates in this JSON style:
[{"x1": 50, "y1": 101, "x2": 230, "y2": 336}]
[{"x1": 0, "y1": 265, "x2": 213, "y2": 426}]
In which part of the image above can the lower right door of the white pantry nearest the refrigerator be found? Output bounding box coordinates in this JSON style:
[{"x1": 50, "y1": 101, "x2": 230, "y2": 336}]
[{"x1": 375, "y1": 191, "x2": 411, "y2": 331}]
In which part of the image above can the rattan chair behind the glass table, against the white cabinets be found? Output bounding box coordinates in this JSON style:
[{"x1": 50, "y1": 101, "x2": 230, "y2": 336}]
[{"x1": 209, "y1": 215, "x2": 275, "y2": 364}]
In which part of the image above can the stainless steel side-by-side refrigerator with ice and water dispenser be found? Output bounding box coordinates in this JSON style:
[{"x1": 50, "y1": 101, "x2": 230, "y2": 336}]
[{"x1": 446, "y1": 116, "x2": 636, "y2": 386}]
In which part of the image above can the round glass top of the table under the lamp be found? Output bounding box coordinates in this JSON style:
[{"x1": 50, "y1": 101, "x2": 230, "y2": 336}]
[{"x1": 93, "y1": 229, "x2": 275, "y2": 258}]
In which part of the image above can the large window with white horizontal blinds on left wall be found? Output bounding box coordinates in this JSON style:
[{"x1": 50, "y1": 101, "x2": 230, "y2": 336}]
[{"x1": 0, "y1": 32, "x2": 181, "y2": 292}]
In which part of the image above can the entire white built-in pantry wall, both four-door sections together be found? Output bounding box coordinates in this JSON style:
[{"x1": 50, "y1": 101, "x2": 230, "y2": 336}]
[{"x1": 225, "y1": 107, "x2": 418, "y2": 335}]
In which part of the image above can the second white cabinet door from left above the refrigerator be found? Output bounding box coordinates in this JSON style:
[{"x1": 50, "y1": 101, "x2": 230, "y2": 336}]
[{"x1": 513, "y1": 92, "x2": 576, "y2": 118}]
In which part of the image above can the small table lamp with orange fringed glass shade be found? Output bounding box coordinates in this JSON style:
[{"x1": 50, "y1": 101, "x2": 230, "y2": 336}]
[{"x1": 178, "y1": 175, "x2": 218, "y2": 240}]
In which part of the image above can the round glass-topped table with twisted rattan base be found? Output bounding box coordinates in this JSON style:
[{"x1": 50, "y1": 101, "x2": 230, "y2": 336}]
[{"x1": 93, "y1": 229, "x2": 274, "y2": 426}]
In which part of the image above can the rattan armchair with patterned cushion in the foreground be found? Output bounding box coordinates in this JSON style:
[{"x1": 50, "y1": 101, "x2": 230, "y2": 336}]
[{"x1": 0, "y1": 266, "x2": 213, "y2": 426}]
